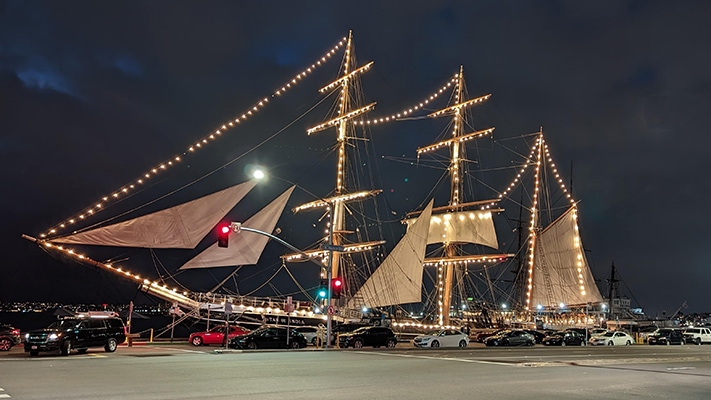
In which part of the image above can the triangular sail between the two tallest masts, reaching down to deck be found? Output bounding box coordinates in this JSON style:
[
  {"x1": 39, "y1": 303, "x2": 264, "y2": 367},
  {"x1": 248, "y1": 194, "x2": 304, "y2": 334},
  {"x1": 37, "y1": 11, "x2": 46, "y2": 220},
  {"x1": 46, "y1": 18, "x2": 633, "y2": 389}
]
[{"x1": 346, "y1": 200, "x2": 434, "y2": 308}]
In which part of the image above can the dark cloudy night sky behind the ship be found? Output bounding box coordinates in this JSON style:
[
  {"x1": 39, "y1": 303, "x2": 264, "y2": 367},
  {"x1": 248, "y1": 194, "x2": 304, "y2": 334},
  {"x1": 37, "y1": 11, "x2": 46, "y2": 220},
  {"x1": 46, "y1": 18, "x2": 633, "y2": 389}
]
[{"x1": 0, "y1": 0, "x2": 711, "y2": 316}]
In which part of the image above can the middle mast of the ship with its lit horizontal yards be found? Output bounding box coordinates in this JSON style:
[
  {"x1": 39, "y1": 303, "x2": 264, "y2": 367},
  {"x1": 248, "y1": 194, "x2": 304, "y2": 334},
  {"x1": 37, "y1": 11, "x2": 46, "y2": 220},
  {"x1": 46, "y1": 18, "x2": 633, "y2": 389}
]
[{"x1": 417, "y1": 66, "x2": 512, "y2": 325}]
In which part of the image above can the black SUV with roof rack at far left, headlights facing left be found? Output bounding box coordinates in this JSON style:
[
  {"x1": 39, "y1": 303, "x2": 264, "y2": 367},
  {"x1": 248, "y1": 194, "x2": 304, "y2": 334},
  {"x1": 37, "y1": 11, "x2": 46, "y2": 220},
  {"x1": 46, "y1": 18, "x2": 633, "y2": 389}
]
[{"x1": 25, "y1": 317, "x2": 126, "y2": 356}]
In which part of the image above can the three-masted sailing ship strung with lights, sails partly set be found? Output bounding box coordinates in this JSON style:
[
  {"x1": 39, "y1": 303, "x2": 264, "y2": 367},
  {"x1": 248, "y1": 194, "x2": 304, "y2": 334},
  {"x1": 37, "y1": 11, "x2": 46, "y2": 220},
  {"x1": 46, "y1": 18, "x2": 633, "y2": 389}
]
[{"x1": 20, "y1": 30, "x2": 602, "y2": 332}]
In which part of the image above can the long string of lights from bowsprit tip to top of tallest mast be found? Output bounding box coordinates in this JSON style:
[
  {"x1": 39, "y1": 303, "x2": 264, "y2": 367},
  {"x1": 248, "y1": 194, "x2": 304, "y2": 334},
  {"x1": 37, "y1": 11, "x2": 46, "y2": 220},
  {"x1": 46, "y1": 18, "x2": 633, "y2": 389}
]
[{"x1": 39, "y1": 38, "x2": 346, "y2": 239}]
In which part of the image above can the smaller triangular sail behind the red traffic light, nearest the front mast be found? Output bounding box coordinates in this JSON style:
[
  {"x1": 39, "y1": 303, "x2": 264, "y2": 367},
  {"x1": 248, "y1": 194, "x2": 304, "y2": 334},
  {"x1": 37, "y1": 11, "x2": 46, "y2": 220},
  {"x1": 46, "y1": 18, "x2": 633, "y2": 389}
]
[{"x1": 180, "y1": 186, "x2": 294, "y2": 269}]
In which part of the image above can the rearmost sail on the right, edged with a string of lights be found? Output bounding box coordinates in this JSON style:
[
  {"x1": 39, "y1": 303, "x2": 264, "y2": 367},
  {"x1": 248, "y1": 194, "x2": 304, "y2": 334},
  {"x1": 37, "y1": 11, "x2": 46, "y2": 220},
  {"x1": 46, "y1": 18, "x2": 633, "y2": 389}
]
[{"x1": 530, "y1": 207, "x2": 602, "y2": 309}]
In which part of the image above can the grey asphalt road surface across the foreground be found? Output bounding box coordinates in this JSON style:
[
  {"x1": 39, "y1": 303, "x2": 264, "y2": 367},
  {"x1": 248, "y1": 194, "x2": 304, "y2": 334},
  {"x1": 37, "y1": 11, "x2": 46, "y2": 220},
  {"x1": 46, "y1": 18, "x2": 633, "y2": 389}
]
[{"x1": 0, "y1": 342, "x2": 711, "y2": 400}]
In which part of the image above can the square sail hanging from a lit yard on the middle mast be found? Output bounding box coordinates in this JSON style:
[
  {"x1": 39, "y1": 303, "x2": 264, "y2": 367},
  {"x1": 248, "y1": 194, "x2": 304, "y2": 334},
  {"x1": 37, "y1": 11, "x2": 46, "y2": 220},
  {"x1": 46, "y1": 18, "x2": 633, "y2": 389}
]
[{"x1": 406, "y1": 210, "x2": 499, "y2": 249}]
